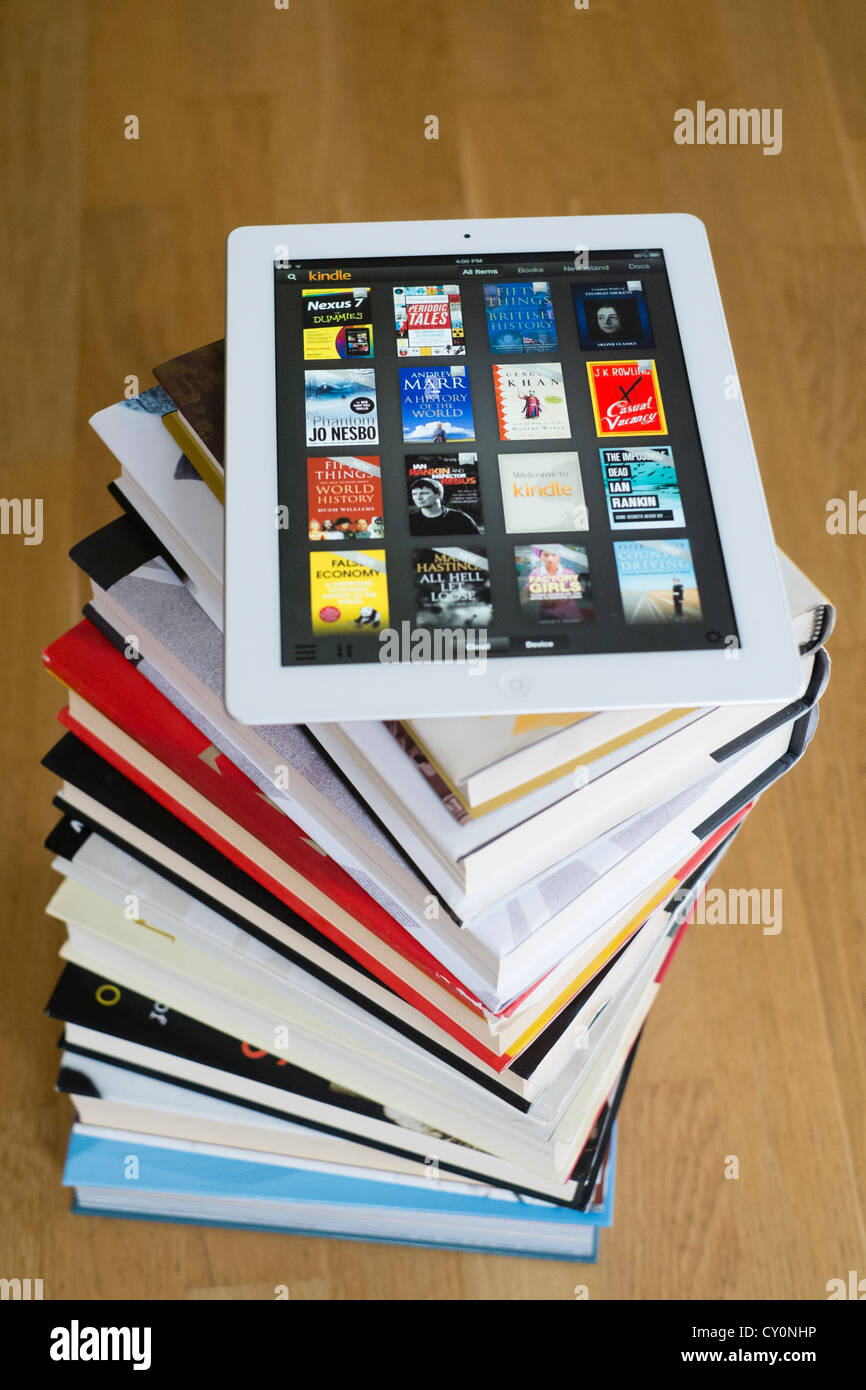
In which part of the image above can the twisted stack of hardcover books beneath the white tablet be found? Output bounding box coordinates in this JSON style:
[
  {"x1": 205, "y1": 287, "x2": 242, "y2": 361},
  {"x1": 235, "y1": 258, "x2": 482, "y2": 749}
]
[{"x1": 44, "y1": 343, "x2": 833, "y2": 1259}]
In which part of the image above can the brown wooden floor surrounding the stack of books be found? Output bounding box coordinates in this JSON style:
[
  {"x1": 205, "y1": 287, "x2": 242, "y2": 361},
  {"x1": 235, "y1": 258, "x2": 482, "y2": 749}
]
[{"x1": 0, "y1": 0, "x2": 866, "y2": 1300}]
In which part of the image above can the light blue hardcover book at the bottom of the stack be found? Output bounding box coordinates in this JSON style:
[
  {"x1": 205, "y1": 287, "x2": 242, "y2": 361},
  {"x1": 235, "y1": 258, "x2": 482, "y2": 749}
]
[{"x1": 63, "y1": 1125, "x2": 616, "y2": 1259}]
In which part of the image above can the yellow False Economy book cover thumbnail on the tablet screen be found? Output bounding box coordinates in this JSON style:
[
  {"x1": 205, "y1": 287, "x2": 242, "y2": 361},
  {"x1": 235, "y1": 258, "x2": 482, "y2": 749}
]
[{"x1": 310, "y1": 550, "x2": 388, "y2": 637}]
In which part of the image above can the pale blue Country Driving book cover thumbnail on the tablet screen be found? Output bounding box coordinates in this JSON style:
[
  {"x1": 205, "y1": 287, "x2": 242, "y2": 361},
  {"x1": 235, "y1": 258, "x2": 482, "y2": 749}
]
[{"x1": 613, "y1": 541, "x2": 701, "y2": 623}]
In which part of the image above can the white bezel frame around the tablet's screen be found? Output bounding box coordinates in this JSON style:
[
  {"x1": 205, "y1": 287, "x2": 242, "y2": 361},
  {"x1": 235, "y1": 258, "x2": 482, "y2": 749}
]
[{"x1": 225, "y1": 213, "x2": 799, "y2": 723}]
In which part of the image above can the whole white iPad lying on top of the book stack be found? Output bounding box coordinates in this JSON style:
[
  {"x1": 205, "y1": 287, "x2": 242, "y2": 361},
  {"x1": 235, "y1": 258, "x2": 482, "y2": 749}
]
[{"x1": 225, "y1": 214, "x2": 799, "y2": 723}]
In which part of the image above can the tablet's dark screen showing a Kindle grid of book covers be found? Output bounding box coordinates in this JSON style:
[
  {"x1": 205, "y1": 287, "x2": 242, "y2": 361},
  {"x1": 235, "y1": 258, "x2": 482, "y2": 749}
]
[{"x1": 274, "y1": 249, "x2": 738, "y2": 666}]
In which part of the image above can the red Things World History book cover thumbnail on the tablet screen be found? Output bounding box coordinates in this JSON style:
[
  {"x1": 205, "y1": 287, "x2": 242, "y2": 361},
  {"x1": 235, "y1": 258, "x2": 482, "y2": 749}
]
[{"x1": 307, "y1": 455, "x2": 385, "y2": 541}]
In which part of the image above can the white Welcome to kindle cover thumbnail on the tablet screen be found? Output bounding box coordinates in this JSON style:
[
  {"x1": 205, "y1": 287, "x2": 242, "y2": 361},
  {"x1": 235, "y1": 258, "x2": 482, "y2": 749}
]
[{"x1": 499, "y1": 452, "x2": 589, "y2": 534}]
